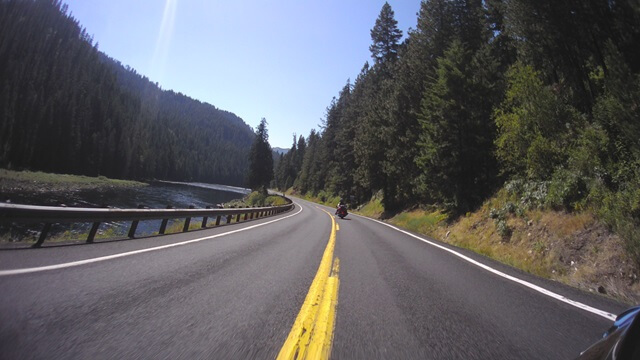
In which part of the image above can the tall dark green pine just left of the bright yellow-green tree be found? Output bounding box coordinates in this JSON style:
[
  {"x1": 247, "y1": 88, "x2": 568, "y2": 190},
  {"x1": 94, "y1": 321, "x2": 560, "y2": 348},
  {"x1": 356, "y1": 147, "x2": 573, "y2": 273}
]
[{"x1": 416, "y1": 40, "x2": 495, "y2": 213}]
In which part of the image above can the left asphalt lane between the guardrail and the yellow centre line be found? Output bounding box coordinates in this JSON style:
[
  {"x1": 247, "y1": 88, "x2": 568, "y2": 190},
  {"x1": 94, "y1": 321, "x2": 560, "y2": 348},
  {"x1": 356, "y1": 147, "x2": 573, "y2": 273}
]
[{"x1": 0, "y1": 207, "x2": 324, "y2": 359}]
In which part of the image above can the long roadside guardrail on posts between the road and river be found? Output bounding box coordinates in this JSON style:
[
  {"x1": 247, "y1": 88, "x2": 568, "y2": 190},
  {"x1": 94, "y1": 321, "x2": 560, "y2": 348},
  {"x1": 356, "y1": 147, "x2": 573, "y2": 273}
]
[{"x1": 0, "y1": 199, "x2": 293, "y2": 247}]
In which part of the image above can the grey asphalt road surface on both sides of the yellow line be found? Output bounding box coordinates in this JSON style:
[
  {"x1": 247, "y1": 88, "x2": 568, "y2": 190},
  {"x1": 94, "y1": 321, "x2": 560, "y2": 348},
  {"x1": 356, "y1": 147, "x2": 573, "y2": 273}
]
[{"x1": 0, "y1": 200, "x2": 625, "y2": 359}]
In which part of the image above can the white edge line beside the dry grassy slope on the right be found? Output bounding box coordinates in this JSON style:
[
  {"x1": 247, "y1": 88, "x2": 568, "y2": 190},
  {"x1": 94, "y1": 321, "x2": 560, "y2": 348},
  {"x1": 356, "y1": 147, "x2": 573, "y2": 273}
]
[{"x1": 353, "y1": 214, "x2": 616, "y2": 321}]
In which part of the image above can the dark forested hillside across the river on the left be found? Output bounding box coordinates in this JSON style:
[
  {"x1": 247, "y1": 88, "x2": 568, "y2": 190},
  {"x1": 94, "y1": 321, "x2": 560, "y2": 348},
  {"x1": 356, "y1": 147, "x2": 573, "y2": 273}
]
[{"x1": 0, "y1": 0, "x2": 255, "y2": 185}]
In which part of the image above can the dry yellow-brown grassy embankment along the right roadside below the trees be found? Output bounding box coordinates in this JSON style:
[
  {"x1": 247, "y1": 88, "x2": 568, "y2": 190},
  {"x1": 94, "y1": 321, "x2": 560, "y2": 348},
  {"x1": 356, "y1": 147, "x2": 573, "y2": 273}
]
[{"x1": 288, "y1": 190, "x2": 640, "y2": 304}]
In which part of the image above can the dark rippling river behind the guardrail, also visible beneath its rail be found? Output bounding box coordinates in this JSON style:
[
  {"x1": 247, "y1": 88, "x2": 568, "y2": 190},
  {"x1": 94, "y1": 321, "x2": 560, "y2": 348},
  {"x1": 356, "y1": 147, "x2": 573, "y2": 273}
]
[{"x1": 0, "y1": 182, "x2": 249, "y2": 242}]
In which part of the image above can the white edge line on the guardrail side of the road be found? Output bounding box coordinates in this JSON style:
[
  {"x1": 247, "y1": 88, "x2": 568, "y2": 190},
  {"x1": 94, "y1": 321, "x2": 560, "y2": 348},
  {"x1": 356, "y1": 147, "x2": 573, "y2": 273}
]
[{"x1": 0, "y1": 203, "x2": 302, "y2": 276}]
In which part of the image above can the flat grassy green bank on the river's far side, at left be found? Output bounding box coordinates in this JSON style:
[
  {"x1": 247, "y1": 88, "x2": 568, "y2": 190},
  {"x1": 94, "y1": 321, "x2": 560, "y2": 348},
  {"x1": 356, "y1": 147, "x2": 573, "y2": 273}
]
[{"x1": 0, "y1": 169, "x2": 148, "y2": 195}]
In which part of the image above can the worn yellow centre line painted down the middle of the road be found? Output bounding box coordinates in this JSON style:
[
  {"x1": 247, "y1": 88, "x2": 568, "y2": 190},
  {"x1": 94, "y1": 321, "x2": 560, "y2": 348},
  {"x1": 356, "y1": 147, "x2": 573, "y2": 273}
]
[{"x1": 277, "y1": 210, "x2": 340, "y2": 359}]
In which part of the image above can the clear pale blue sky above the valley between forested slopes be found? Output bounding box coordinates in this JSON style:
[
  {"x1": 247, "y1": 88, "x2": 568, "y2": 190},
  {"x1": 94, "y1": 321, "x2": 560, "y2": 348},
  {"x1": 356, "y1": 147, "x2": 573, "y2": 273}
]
[{"x1": 65, "y1": 0, "x2": 420, "y2": 148}]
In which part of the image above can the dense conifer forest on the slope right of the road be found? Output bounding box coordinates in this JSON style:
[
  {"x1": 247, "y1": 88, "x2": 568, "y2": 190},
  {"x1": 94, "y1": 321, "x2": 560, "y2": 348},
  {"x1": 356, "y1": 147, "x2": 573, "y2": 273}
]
[{"x1": 275, "y1": 0, "x2": 640, "y2": 263}]
